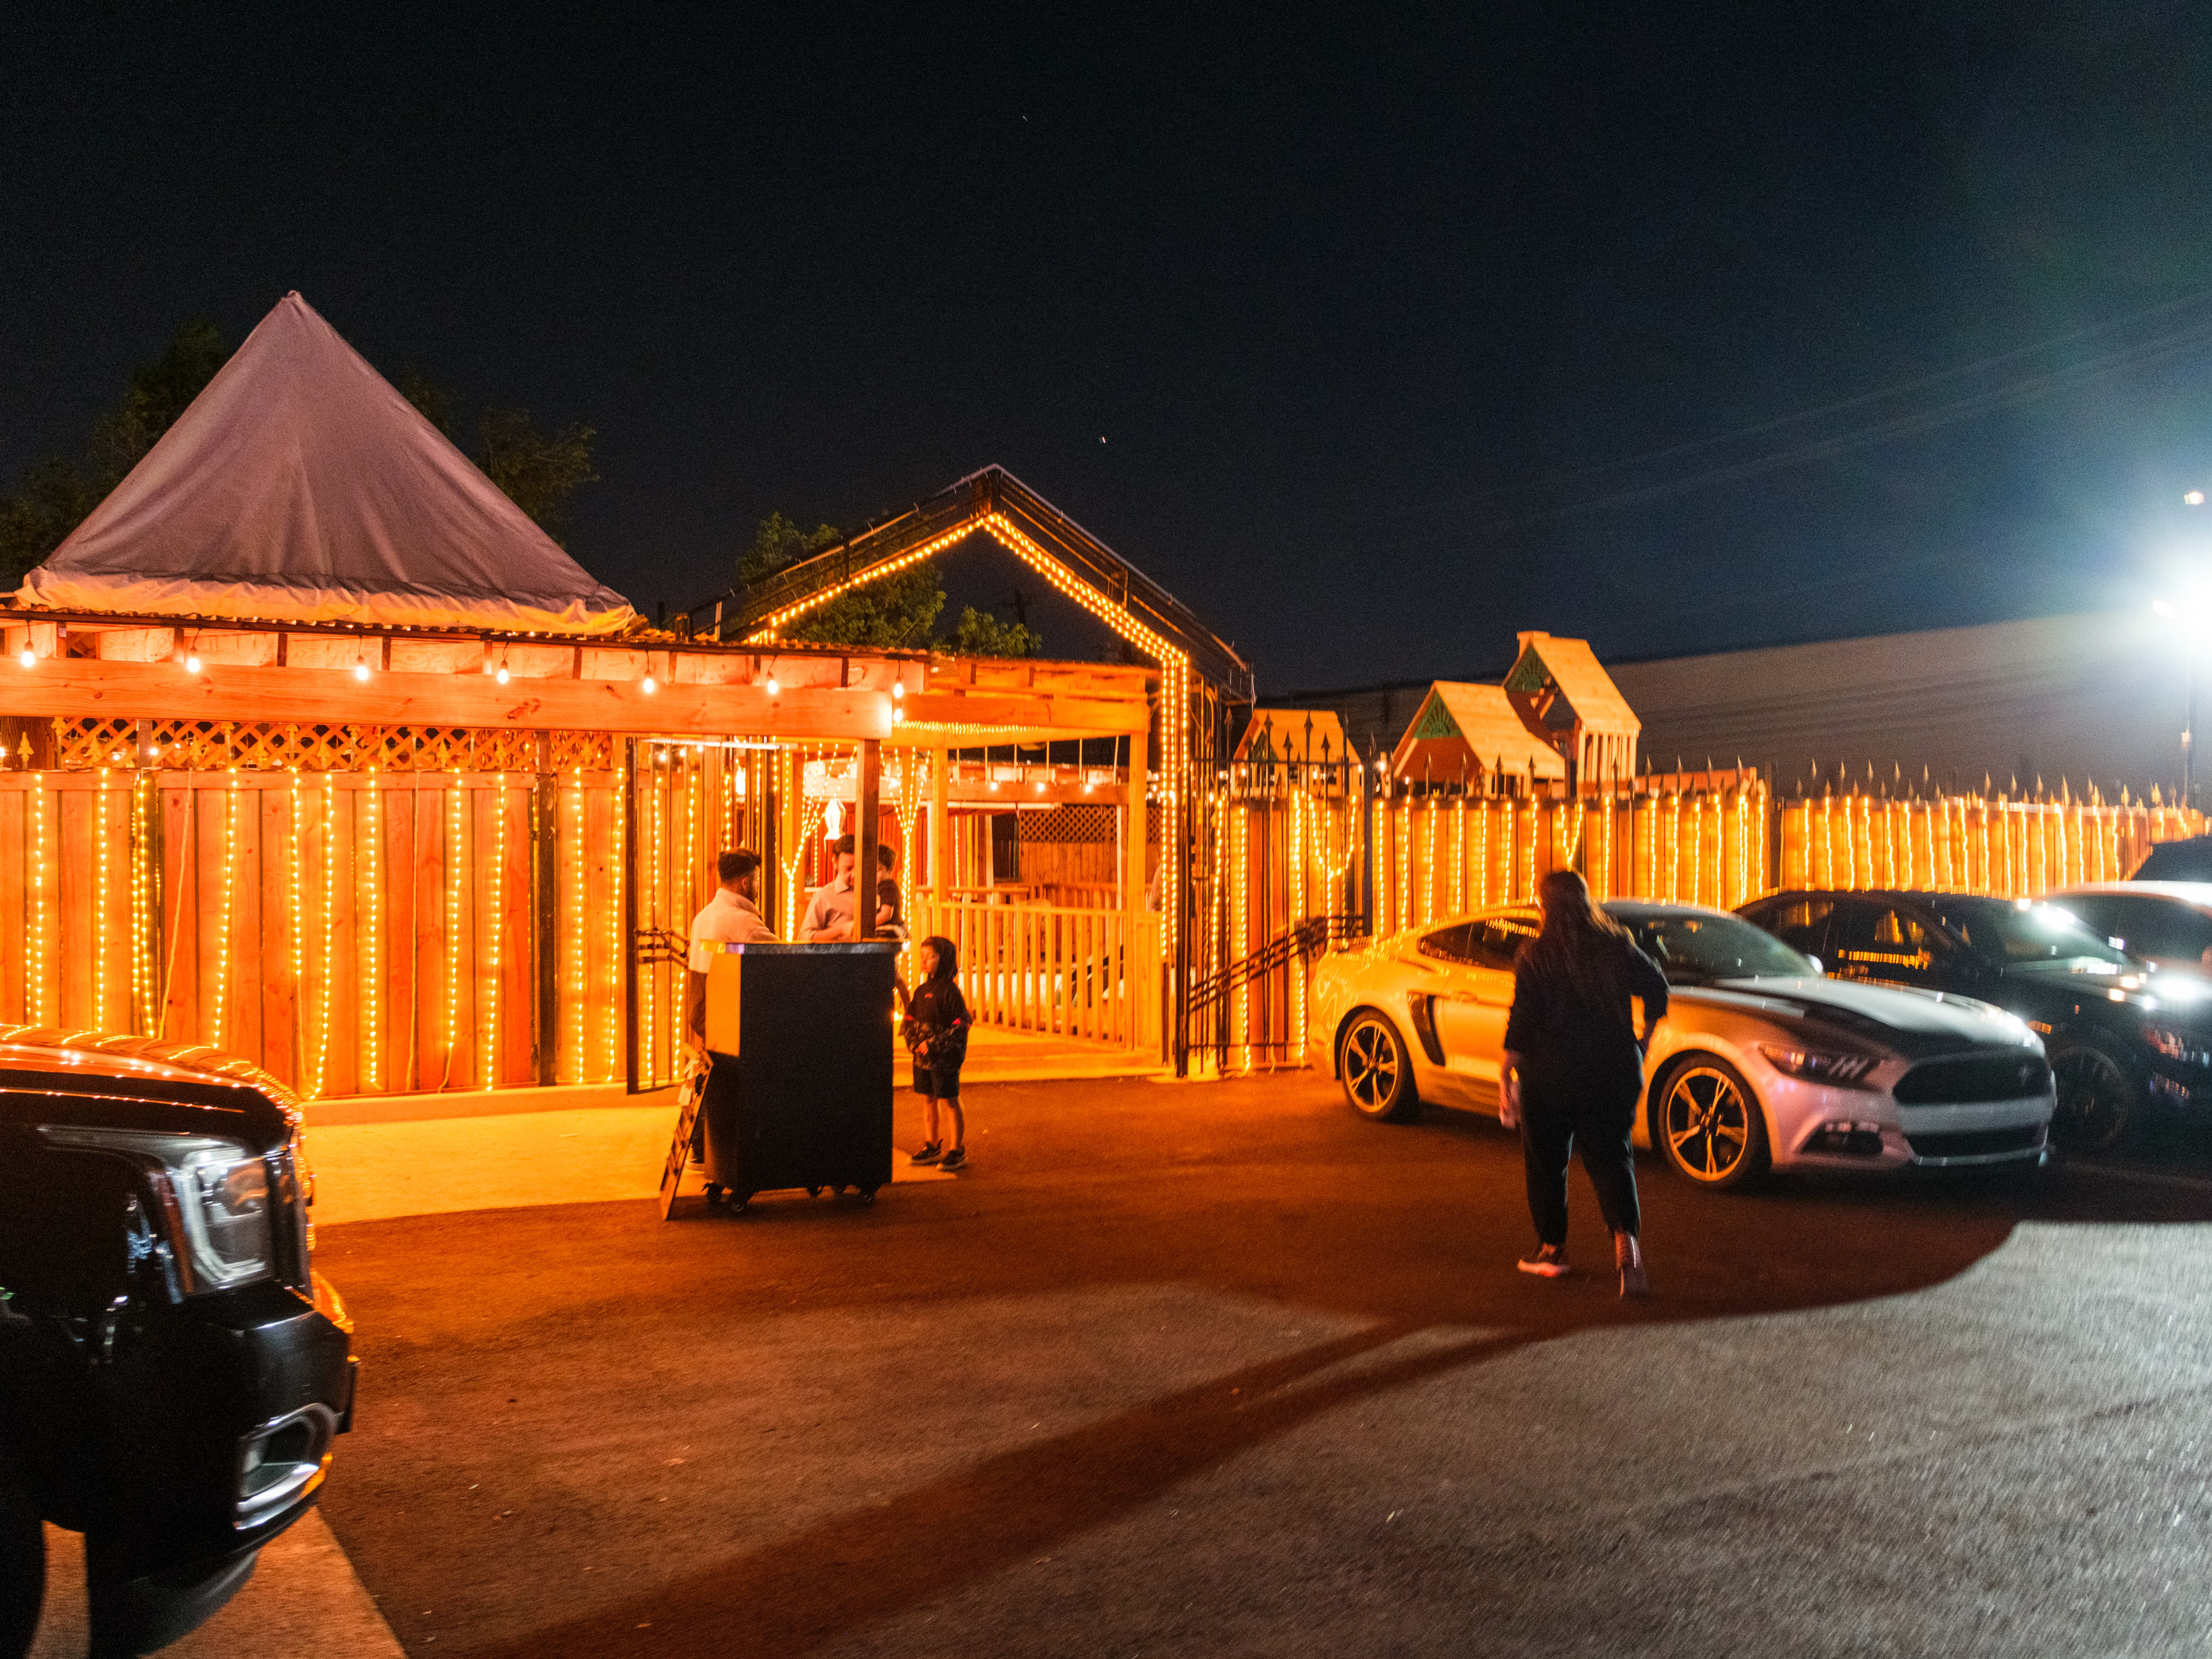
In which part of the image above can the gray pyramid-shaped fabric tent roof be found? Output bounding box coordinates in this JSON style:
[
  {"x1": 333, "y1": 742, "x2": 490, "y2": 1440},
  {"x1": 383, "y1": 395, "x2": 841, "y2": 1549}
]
[{"x1": 18, "y1": 294, "x2": 637, "y2": 635}]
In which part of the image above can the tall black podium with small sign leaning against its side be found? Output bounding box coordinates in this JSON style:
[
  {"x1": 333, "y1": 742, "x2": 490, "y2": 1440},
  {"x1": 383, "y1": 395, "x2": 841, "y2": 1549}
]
[{"x1": 661, "y1": 940, "x2": 900, "y2": 1214}]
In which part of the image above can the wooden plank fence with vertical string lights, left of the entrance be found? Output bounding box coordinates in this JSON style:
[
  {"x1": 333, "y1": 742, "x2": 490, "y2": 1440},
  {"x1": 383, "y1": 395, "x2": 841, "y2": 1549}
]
[{"x1": 0, "y1": 770, "x2": 624, "y2": 1097}]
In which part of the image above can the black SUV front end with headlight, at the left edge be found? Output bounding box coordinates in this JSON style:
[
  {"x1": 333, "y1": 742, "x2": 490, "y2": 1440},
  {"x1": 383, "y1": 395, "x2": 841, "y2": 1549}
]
[{"x1": 0, "y1": 1027, "x2": 354, "y2": 1659}]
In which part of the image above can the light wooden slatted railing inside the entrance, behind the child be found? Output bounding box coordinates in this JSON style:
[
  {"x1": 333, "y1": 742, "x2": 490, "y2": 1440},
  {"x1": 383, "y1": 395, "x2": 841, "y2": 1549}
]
[{"x1": 914, "y1": 893, "x2": 1159, "y2": 1046}]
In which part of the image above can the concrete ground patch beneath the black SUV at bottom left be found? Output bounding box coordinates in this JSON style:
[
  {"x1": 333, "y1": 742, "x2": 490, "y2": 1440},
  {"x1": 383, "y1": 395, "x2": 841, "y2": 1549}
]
[{"x1": 26, "y1": 1513, "x2": 400, "y2": 1659}]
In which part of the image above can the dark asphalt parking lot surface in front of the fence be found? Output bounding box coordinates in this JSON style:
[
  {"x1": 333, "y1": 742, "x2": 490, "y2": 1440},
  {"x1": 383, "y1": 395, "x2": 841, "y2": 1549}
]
[{"x1": 321, "y1": 1077, "x2": 2212, "y2": 1659}]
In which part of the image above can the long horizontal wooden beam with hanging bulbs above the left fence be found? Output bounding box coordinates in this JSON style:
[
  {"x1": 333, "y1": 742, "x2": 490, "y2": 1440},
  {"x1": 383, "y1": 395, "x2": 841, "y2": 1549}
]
[{"x1": 0, "y1": 657, "x2": 898, "y2": 739}]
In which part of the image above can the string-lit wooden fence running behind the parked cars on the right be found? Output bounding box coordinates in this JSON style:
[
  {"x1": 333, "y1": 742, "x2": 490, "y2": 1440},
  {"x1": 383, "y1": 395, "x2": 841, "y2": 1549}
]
[{"x1": 1190, "y1": 781, "x2": 2205, "y2": 1071}]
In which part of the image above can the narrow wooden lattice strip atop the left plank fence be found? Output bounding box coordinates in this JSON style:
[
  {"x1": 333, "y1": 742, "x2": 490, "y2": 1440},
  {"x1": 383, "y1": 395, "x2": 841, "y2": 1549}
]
[{"x1": 53, "y1": 719, "x2": 617, "y2": 772}]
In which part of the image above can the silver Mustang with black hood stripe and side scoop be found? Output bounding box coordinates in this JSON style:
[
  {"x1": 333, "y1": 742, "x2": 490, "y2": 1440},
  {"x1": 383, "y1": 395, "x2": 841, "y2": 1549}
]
[{"x1": 1312, "y1": 900, "x2": 2053, "y2": 1188}]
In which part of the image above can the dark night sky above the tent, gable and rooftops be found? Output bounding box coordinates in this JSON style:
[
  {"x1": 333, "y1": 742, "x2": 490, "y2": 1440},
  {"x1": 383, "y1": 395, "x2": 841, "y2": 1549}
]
[{"x1": 0, "y1": 0, "x2": 2212, "y2": 690}]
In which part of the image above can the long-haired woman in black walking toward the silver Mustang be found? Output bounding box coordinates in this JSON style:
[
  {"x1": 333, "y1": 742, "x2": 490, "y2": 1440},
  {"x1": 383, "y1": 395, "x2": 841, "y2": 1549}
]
[{"x1": 1502, "y1": 869, "x2": 1666, "y2": 1296}]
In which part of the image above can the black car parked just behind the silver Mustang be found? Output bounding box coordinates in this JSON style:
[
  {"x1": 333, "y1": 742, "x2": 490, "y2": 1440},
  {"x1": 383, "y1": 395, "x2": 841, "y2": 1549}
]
[{"x1": 1741, "y1": 892, "x2": 2212, "y2": 1150}]
